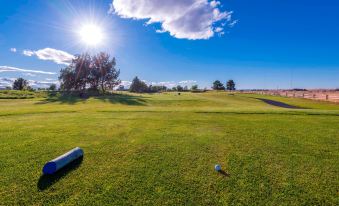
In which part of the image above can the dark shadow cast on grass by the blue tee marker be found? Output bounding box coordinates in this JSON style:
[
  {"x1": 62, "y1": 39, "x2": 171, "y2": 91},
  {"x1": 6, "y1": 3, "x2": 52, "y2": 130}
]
[{"x1": 37, "y1": 157, "x2": 83, "y2": 191}]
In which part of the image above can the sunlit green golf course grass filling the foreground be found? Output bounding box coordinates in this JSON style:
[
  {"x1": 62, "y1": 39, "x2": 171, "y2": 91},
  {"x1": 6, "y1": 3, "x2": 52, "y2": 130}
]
[{"x1": 0, "y1": 92, "x2": 339, "y2": 205}]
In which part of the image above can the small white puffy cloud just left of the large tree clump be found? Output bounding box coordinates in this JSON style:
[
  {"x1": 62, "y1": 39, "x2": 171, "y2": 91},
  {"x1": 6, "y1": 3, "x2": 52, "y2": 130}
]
[{"x1": 23, "y1": 48, "x2": 74, "y2": 65}]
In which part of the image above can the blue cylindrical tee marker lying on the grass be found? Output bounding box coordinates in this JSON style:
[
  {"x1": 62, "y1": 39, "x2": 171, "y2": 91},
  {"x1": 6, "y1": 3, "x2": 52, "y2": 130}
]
[{"x1": 42, "y1": 147, "x2": 84, "y2": 175}]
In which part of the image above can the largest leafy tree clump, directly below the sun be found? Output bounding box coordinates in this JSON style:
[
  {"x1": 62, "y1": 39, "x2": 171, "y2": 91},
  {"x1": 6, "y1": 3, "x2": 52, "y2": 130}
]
[{"x1": 59, "y1": 52, "x2": 120, "y2": 92}]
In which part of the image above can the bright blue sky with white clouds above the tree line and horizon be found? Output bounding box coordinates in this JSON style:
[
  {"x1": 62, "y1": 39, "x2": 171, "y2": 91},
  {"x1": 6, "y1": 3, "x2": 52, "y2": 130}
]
[{"x1": 0, "y1": 0, "x2": 339, "y2": 89}]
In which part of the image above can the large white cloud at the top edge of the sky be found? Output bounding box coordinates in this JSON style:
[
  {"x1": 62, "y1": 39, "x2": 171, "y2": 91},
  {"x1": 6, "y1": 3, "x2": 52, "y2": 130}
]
[{"x1": 110, "y1": 0, "x2": 236, "y2": 40}]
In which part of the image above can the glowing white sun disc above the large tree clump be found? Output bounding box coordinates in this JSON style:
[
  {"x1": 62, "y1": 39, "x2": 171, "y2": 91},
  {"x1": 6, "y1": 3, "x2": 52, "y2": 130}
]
[{"x1": 79, "y1": 24, "x2": 104, "y2": 46}]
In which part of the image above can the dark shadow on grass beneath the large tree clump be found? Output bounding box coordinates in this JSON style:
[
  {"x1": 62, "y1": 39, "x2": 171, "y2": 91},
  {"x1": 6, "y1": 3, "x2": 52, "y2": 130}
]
[{"x1": 36, "y1": 94, "x2": 146, "y2": 106}]
